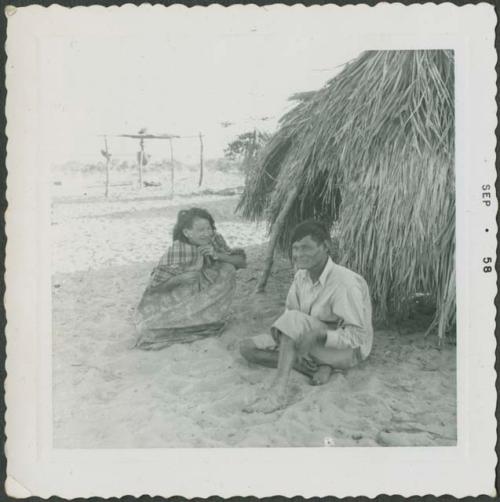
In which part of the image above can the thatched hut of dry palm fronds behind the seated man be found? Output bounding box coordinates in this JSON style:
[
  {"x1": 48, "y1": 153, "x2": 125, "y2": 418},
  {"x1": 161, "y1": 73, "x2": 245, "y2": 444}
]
[{"x1": 239, "y1": 50, "x2": 455, "y2": 337}]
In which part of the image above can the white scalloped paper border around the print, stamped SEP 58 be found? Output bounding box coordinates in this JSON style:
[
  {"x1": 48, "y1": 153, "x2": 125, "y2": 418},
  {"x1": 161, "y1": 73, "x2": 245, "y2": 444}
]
[{"x1": 5, "y1": 4, "x2": 497, "y2": 498}]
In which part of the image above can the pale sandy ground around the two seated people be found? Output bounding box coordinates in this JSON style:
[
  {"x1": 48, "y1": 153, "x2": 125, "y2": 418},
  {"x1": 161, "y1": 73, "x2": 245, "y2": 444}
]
[{"x1": 52, "y1": 192, "x2": 456, "y2": 448}]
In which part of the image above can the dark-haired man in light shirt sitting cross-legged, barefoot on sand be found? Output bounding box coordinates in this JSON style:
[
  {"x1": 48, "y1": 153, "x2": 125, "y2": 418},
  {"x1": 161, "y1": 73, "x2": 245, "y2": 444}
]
[{"x1": 240, "y1": 221, "x2": 373, "y2": 413}]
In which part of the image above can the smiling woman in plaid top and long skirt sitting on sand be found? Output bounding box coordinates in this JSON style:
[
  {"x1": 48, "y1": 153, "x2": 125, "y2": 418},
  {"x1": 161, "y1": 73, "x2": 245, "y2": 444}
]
[{"x1": 137, "y1": 207, "x2": 246, "y2": 349}]
